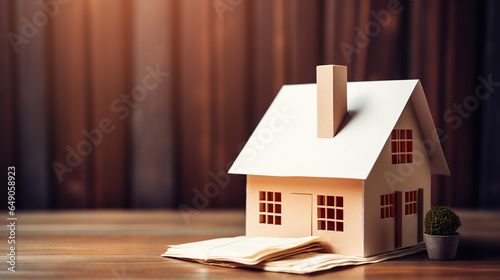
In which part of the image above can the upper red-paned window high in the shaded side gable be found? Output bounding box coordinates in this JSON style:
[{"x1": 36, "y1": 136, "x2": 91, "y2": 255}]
[{"x1": 391, "y1": 129, "x2": 413, "y2": 164}]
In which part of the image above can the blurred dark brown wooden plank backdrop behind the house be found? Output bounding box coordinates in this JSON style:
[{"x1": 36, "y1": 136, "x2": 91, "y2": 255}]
[{"x1": 0, "y1": 0, "x2": 500, "y2": 210}]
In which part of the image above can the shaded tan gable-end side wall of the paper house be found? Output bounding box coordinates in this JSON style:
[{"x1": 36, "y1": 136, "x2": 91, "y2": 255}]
[{"x1": 363, "y1": 101, "x2": 431, "y2": 256}]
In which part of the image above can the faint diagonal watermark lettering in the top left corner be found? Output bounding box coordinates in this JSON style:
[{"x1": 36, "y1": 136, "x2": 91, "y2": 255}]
[{"x1": 7, "y1": 0, "x2": 71, "y2": 54}]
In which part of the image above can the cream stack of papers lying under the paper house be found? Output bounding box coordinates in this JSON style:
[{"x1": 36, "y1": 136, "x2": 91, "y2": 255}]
[{"x1": 162, "y1": 236, "x2": 425, "y2": 274}]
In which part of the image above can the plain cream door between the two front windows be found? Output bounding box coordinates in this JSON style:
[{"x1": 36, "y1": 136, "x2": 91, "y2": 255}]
[{"x1": 290, "y1": 193, "x2": 312, "y2": 237}]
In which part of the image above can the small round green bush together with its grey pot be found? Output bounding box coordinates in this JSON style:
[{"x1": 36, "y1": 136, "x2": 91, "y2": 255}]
[{"x1": 424, "y1": 206, "x2": 462, "y2": 261}]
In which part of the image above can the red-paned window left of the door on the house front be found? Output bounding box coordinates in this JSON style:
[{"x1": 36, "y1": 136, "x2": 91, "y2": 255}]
[{"x1": 259, "y1": 192, "x2": 281, "y2": 225}]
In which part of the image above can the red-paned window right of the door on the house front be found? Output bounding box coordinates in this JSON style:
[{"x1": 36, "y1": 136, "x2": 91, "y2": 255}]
[{"x1": 317, "y1": 195, "x2": 344, "y2": 232}]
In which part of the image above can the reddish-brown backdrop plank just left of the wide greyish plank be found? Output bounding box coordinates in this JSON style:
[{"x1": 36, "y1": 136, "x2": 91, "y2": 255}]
[{"x1": 86, "y1": 0, "x2": 134, "y2": 207}]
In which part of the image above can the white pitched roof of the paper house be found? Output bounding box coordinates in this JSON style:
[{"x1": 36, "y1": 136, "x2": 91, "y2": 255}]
[{"x1": 229, "y1": 80, "x2": 449, "y2": 179}]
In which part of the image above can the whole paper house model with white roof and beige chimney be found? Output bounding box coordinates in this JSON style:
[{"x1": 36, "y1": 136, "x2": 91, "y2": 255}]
[{"x1": 229, "y1": 65, "x2": 449, "y2": 256}]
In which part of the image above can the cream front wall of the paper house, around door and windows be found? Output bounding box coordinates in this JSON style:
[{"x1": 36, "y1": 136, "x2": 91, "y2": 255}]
[{"x1": 246, "y1": 175, "x2": 363, "y2": 256}]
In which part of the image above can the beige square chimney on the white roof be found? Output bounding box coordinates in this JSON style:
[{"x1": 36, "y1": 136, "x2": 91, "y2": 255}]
[{"x1": 316, "y1": 65, "x2": 347, "y2": 138}]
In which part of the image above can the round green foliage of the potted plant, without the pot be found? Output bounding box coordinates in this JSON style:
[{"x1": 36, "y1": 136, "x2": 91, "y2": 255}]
[{"x1": 424, "y1": 206, "x2": 462, "y2": 235}]
